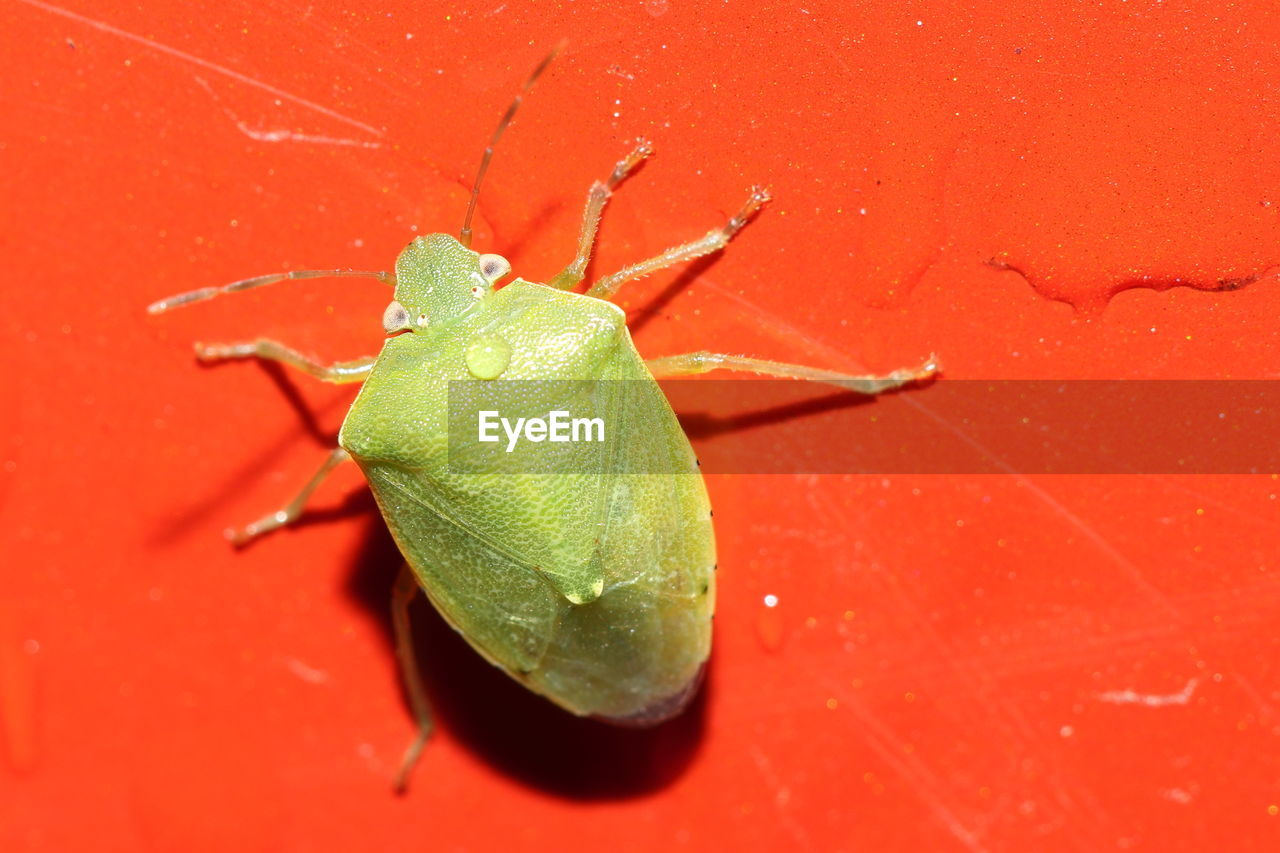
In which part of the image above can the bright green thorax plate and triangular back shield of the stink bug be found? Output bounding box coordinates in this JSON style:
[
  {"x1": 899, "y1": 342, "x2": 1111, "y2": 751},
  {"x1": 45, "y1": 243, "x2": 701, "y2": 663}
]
[{"x1": 340, "y1": 280, "x2": 639, "y2": 605}]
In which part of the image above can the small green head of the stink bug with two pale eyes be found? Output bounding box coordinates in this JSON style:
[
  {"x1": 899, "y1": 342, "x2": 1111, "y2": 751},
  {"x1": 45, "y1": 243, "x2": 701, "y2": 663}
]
[{"x1": 383, "y1": 234, "x2": 511, "y2": 334}]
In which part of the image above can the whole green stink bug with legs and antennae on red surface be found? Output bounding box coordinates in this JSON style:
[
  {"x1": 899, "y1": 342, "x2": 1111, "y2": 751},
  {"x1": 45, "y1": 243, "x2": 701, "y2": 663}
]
[{"x1": 148, "y1": 53, "x2": 936, "y2": 789}]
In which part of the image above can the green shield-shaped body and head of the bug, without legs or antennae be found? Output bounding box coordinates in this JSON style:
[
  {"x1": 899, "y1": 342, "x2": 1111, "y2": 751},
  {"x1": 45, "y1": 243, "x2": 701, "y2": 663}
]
[{"x1": 339, "y1": 234, "x2": 716, "y2": 724}]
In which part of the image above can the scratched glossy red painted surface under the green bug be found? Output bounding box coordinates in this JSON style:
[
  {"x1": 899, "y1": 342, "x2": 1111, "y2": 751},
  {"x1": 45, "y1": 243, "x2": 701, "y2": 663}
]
[{"x1": 0, "y1": 0, "x2": 1280, "y2": 850}]
